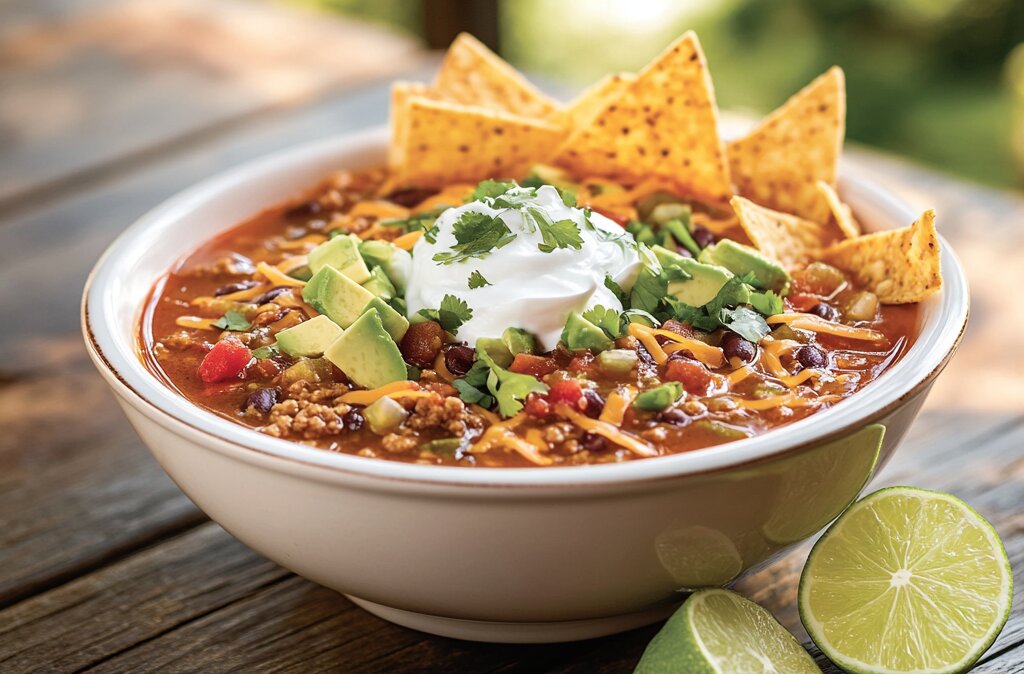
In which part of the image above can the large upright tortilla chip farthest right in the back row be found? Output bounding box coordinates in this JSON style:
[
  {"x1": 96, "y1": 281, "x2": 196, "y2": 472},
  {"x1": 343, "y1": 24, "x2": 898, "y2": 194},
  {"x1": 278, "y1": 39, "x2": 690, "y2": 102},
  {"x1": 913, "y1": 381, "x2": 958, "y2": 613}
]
[{"x1": 728, "y1": 67, "x2": 846, "y2": 222}]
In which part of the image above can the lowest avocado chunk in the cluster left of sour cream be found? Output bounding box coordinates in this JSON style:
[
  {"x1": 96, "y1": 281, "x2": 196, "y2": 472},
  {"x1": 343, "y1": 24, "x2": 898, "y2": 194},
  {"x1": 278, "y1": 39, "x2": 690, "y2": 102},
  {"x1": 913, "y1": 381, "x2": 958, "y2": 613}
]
[{"x1": 324, "y1": 309, "x2": 406, "y2": 388}]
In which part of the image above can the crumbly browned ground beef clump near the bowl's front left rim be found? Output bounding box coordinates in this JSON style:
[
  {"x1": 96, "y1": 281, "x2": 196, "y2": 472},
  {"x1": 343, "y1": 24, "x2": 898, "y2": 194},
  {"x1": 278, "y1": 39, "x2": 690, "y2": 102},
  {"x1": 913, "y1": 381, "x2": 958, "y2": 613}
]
[{"x1": 261, "y1": 381, "x2": 352, "y2": 440}]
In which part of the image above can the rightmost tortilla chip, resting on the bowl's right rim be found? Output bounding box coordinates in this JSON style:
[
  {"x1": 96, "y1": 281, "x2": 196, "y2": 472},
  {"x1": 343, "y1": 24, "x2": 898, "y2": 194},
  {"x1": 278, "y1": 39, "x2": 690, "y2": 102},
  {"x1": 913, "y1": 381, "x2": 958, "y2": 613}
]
[{"x1": 821, "y1": 210, "x2": 942, "y2": 304}]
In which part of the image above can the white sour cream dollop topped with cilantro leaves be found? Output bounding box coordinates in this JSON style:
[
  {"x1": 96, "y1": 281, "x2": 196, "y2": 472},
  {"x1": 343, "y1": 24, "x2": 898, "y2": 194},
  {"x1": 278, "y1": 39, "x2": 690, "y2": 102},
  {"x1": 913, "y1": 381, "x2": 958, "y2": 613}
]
[{"x1": 406, "y1": 185, "x2": 641, "y2": 350}]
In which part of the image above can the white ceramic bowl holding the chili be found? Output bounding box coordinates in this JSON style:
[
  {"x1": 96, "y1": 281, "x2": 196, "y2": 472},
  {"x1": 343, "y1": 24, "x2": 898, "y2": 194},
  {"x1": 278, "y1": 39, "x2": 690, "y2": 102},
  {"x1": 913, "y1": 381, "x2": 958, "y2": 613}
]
[{"x1": 83, "y1": 129, "x2": 968, "y2": 642}]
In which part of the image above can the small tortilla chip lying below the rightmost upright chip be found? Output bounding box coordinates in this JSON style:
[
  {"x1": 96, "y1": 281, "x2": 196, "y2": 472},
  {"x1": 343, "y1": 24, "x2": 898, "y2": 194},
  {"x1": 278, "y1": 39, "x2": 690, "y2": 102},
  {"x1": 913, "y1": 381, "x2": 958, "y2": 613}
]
[{"x1": 730, "y1": 197, "x2": 834, "y2": 268}]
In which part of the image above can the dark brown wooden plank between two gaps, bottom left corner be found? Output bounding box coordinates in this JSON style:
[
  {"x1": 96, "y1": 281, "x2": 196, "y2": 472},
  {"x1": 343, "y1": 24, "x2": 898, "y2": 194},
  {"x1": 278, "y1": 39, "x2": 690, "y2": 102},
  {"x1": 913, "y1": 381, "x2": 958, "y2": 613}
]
[{"x1": 0, "y1": 523, "x2": 289, "y2": 672}]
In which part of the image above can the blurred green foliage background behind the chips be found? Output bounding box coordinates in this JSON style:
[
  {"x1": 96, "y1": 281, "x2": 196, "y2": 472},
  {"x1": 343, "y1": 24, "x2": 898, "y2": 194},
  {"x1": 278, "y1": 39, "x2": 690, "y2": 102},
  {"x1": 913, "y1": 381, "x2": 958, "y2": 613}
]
[{"x1": 290, "y1": 0, "x2": 1024, "y2": 189}]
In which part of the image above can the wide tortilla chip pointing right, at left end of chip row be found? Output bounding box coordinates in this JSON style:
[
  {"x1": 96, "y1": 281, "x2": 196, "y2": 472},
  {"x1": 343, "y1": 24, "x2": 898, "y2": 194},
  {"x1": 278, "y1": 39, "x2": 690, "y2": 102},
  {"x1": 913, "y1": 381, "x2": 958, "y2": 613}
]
[{"x1": 391, "y1": 95, "x2": 565, "y2": 187}]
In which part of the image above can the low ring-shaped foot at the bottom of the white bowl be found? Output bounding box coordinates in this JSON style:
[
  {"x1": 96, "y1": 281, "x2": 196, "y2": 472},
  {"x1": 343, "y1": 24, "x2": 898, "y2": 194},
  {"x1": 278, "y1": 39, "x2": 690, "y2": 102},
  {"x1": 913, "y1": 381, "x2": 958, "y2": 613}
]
[{"x1": 345, "y1": 594, "x2": 679, "y2": 643}]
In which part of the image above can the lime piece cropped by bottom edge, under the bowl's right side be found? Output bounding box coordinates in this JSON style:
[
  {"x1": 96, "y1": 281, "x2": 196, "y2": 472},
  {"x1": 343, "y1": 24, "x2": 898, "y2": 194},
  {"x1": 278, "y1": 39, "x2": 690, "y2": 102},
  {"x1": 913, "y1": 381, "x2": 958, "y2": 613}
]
[{"x1": 636, "y1": 588, "x2": 821, "y2": 674}]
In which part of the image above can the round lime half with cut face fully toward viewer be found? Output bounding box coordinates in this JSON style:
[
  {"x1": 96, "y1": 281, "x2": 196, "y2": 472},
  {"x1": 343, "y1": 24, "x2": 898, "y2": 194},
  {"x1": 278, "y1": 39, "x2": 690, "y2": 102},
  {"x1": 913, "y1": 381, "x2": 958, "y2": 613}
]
[{"x1": 800, "y1": 487, "x2": 1013, "y2": 674}]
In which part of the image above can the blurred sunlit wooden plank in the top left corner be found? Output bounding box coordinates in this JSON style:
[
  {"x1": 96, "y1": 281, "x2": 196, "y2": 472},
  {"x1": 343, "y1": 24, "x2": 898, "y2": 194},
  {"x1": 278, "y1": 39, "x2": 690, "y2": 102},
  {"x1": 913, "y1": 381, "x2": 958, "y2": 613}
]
[{"x1": 0, "y1": 0, "x2": 424, "y2": 204}]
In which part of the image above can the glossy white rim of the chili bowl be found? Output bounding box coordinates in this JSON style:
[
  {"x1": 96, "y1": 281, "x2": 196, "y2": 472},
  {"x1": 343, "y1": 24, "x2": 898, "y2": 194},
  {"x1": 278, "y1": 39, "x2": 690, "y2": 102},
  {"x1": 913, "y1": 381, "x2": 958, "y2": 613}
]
[{"x1": 81, "y1": 127, "x2": 970, "y2": 488}]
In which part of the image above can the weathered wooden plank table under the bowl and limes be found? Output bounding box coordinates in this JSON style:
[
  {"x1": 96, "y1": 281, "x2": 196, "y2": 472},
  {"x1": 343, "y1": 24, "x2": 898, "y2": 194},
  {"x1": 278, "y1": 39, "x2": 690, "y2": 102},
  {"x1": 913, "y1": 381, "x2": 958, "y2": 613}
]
[{"x1": 0, "y1": 0, "x2": 1024, "y2": 672}]
